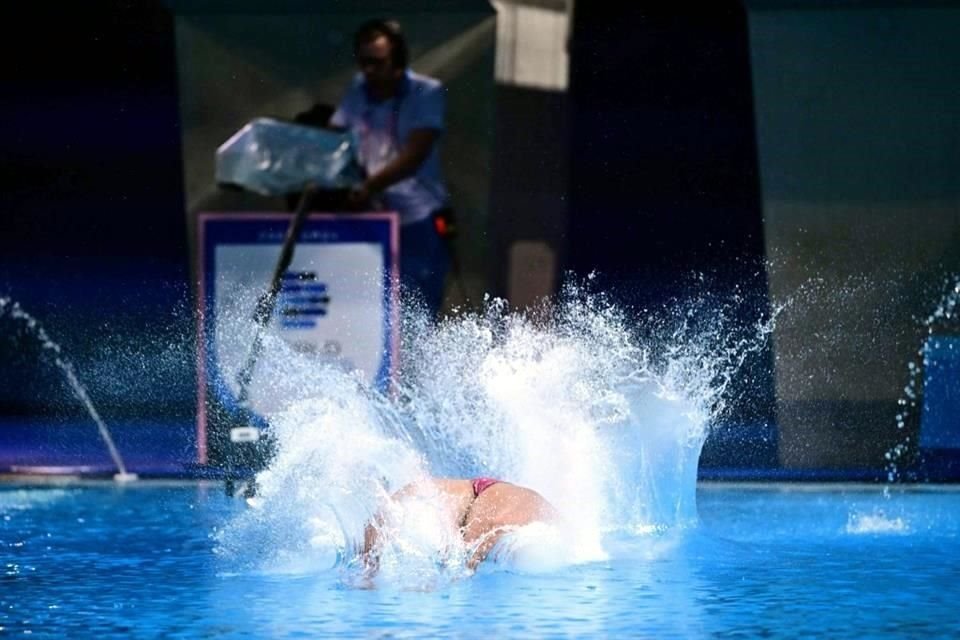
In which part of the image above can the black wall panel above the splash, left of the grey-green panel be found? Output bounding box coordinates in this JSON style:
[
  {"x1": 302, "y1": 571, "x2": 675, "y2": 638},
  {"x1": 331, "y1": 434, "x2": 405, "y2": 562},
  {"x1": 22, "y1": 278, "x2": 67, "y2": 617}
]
[{"x1": 571, "y1": 2, "x2": 764, "y2": 300}]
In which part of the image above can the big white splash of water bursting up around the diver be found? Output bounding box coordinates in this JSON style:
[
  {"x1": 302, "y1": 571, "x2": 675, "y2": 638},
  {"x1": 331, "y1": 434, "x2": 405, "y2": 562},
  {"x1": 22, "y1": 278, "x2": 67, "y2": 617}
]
[{"x1": 216, "y1": 279, "x2": 772, "y2": 585}]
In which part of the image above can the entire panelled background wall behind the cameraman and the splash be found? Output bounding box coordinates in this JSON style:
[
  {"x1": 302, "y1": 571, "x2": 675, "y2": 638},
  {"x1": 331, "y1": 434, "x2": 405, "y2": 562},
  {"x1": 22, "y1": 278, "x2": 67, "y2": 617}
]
[{"x1": 0, "y1": 0, "x2": 960, "y2": 477}]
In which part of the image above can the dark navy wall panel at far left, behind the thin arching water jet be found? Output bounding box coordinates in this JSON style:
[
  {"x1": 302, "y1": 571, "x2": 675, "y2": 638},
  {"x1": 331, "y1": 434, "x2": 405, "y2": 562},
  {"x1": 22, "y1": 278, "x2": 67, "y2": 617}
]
[{"x1": 0, "y1": 2, "x2": 195, "y2": 419}]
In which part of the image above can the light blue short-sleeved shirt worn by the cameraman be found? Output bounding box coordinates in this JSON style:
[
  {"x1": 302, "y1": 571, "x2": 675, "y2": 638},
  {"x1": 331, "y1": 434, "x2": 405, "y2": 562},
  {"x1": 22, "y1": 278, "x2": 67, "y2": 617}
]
[{"x1": 330, "y1": 69, "x2": 447, "y2": 224}]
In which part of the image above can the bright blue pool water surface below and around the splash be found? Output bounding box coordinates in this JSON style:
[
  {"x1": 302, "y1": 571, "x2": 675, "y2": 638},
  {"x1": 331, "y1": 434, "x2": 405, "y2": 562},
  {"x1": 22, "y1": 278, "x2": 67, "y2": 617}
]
[{"x1": 0, "y1": 479, "x2": 960, "y2": 638}]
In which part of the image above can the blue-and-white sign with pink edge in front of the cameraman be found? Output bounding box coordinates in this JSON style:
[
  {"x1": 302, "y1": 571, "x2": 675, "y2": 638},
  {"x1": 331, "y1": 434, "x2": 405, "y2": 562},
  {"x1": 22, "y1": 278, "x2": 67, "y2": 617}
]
[{"x1": 197, "y1": 213, "x2": 399, "y2": 463}]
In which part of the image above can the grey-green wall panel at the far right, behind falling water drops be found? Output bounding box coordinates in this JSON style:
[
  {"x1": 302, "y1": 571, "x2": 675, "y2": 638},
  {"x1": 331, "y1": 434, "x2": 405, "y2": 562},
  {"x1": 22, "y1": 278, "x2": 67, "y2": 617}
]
[{"x1": 750, "y1": 2, "x2": 960, "y2": 468}]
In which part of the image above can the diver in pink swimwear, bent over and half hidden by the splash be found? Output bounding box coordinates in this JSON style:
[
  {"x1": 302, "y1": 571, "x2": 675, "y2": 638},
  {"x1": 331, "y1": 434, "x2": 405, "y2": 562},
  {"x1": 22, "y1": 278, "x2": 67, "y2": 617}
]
[{"x1": 361, "y1": 477, "x2": 561, "y2": 575}]
